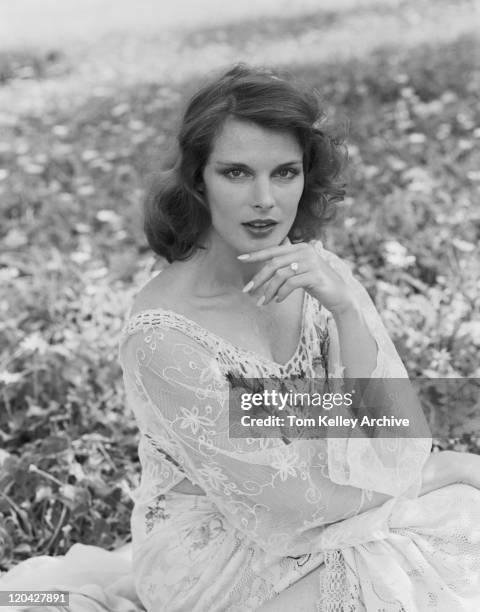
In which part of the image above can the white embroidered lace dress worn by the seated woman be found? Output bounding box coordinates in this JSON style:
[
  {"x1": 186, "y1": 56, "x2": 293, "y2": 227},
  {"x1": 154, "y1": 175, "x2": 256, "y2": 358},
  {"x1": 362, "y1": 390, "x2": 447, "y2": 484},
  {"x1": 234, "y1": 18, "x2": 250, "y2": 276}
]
[{"x1": 120, "y1": 243, "x2": 480, "y2": 612}]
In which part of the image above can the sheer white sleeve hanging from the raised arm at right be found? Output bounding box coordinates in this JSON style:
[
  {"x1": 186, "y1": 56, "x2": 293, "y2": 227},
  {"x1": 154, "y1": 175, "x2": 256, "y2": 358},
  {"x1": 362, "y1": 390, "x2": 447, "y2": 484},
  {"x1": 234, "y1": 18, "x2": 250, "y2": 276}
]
[{"x1": 314, "y1": 241, "x2": 432, "y2": 497}]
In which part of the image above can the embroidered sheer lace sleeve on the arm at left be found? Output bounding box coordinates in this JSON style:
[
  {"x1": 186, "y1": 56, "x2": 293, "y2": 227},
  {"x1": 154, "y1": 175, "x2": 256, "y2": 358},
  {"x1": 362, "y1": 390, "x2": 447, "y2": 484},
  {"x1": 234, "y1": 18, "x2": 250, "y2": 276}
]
[{"x1": 116, "y1": 325, "x2": 404, "y2": 555}]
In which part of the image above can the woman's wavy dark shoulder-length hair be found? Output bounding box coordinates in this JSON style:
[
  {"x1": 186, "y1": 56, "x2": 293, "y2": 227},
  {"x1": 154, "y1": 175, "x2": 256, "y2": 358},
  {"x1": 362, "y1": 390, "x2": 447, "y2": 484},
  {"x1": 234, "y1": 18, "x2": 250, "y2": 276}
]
[{"x1": 144, "y1": 63, "x2": 346, "y2": 262}]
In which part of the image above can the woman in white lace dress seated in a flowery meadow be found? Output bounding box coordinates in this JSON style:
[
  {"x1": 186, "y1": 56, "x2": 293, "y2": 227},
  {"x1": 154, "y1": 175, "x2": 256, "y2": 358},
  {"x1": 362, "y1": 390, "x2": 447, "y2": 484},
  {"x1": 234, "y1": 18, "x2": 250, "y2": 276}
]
[{"x1": 120, "y1": 65, "x2": 480, "y2": 612}]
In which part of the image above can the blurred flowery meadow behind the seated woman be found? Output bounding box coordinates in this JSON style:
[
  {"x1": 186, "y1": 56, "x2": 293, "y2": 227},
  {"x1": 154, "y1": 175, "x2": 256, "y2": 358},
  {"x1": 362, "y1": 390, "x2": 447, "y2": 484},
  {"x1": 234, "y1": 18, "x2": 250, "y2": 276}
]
[{"x1": 0, "y1": 0, "x2": 480, "y2": 569}]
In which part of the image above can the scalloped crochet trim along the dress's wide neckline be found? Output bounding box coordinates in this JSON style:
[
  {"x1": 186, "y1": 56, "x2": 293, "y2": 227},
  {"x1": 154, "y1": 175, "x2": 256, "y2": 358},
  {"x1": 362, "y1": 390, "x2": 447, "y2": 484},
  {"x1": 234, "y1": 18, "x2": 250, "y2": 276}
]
[{"x1": 125, "y1": 291, "x2": 311, "y2": 370}]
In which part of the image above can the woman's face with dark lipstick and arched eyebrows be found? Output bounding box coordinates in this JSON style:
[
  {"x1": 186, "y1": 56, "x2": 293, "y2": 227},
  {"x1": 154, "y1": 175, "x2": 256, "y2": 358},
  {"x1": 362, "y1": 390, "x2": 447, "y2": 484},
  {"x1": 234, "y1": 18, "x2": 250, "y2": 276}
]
[{"x1": 203, "y1": 118, "x2": 304, "y2": 253}]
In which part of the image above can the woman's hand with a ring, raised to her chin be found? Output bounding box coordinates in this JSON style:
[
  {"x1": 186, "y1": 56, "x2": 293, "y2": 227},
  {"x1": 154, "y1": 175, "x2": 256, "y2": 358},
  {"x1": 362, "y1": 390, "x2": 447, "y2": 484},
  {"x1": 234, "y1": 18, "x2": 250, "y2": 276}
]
[{"x1": 238, "y1": 241, "x2": 355, "y2": 315}]
